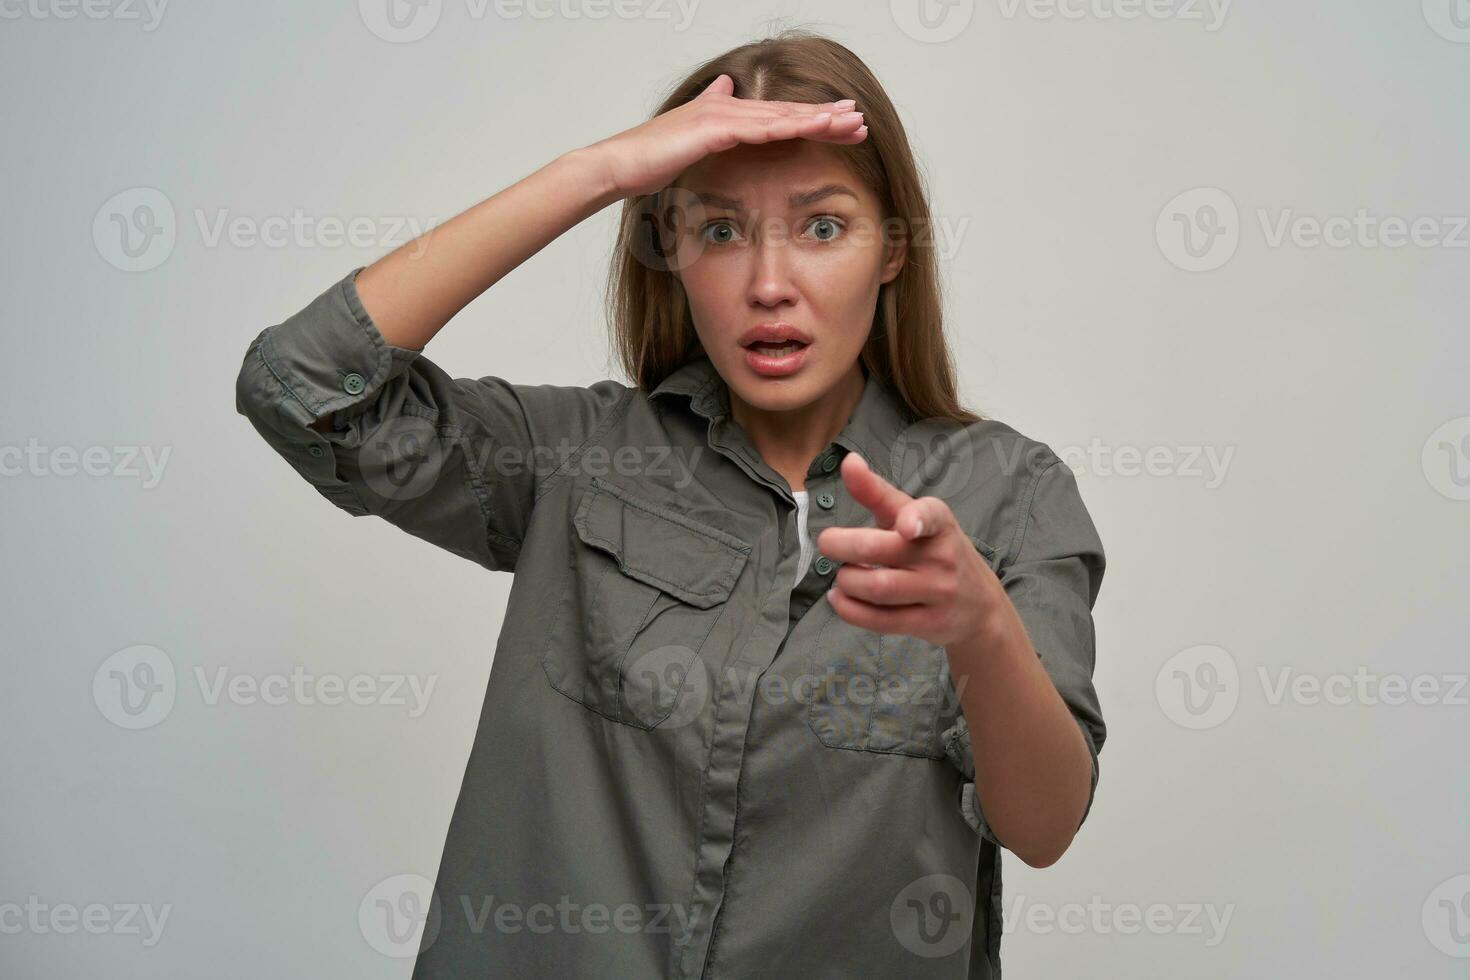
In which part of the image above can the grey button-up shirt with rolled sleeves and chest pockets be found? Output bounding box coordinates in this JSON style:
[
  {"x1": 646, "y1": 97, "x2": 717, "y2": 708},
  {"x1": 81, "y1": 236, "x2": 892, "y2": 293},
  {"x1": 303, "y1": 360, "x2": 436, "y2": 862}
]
[{"x1": 237, "y1": 269, "x2": 1105, "y2": 980}]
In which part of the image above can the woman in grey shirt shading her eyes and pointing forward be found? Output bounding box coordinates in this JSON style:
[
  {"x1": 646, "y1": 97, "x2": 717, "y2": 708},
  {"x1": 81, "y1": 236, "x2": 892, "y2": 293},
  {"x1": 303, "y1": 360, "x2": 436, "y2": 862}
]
[{"x1": 237, "y1": 31, "x2": 1105, "y2": 980}]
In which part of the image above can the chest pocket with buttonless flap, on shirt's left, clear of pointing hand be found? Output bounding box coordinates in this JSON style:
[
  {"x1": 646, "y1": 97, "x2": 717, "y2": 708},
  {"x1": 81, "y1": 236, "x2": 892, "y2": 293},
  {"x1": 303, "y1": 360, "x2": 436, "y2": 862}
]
[{"x1": 541, "y1": 476, "x2": 751, "y2": 729}]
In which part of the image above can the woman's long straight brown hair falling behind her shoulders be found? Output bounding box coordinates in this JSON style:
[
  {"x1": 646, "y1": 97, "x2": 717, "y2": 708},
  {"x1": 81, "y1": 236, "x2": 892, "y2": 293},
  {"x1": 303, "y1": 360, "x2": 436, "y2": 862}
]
[{"x1": 607, "y1": 29, "x2": 982, "y2": 423}]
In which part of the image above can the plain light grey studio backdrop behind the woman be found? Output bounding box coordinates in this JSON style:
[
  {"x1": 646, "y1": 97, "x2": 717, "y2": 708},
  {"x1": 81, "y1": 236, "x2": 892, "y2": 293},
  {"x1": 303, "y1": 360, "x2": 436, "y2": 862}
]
[{"x1": 0, "y1": 0, "x2": 1470, "y2": 979}]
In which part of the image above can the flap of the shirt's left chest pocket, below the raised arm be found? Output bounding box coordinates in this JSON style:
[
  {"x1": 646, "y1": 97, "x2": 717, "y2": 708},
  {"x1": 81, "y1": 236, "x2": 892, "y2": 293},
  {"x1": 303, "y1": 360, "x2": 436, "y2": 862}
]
[{"x1": 573, "y1": 476, "x2": 750, "y2": 608}]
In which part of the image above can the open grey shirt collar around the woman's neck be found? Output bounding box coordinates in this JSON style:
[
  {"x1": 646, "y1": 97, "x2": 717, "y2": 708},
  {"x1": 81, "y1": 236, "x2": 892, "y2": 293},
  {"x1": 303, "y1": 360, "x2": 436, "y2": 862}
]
[{"x1": 648, "y1": 353, "x2": 913, "y2": 483}]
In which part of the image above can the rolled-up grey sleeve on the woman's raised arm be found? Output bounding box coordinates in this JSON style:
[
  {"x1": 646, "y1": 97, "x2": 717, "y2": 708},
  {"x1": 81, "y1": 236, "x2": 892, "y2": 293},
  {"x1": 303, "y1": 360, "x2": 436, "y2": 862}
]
[{"x1": 235, "y1": 266, "x2": 634, "y2": 572}]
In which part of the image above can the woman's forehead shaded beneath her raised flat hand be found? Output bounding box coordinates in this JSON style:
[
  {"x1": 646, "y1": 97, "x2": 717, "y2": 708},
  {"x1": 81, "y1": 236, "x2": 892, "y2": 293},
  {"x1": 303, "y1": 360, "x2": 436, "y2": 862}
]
[{"x1": 676, "y1": 140, "x2": 878, "y2": 210}]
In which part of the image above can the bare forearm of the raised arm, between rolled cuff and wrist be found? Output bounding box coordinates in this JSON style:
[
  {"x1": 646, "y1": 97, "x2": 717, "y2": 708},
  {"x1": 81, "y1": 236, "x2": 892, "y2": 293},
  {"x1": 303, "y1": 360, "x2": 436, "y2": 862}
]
[{"x1": 356, "y1": 147, "x2": 619, "y2": 350}]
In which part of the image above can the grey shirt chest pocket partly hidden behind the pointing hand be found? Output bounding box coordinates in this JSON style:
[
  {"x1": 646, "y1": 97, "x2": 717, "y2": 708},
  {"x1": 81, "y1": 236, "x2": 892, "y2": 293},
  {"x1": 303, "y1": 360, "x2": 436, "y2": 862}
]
[{"x1": 807, "y1": 535, "x2": 997, "y2": 758}]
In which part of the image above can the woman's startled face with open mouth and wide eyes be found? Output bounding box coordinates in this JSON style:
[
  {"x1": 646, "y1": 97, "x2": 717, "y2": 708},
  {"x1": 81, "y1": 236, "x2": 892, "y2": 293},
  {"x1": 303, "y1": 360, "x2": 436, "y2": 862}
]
[{"x1": 672, "y1": 140, "x2": 904, "y2": 411}]
